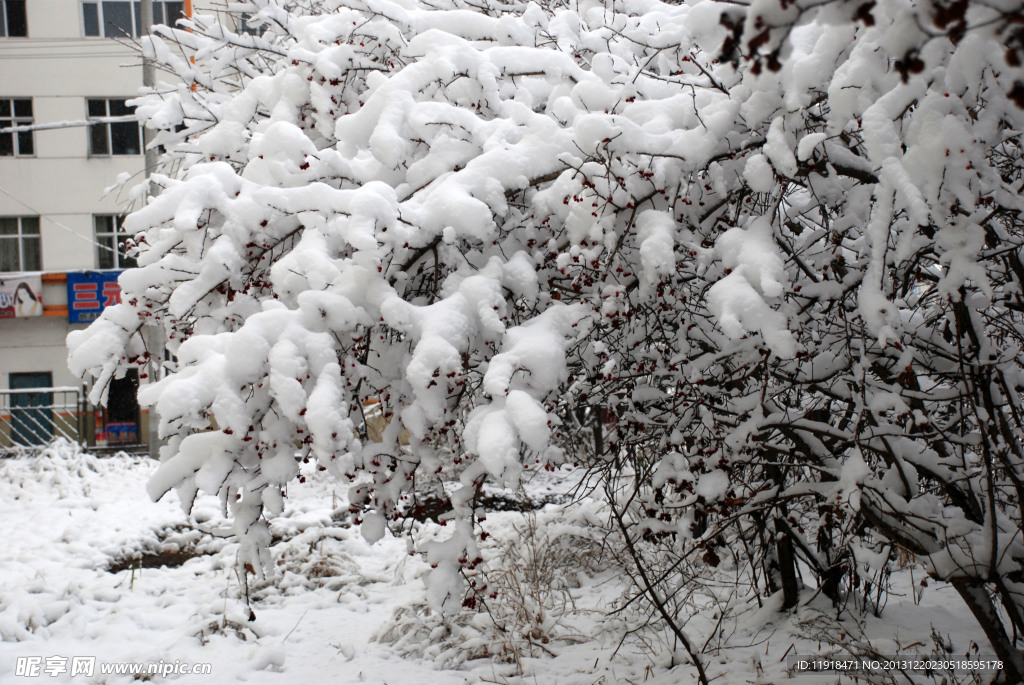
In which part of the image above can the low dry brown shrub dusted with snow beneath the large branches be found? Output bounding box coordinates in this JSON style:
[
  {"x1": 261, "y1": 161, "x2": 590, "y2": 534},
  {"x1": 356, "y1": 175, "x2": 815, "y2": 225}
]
[{"x1": 375, "y1": 501, "x2": 623, "y2": 676}]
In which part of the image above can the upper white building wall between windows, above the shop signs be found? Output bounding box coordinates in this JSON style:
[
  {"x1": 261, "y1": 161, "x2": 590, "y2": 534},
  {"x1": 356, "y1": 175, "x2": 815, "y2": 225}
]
[{"x1": 0, "y1": 0, "x2": 142, "y2": 278}]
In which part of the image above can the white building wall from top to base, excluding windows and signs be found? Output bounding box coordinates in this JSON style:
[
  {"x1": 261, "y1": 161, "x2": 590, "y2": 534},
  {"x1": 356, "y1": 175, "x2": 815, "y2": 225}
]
[{"x1": 0, "y1": 0, "x2": 239, "y2": 444}]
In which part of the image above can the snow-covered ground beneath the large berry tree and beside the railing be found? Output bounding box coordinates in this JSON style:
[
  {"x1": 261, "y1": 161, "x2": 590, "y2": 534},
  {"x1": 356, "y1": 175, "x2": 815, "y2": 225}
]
[{"x1": 0, "y1": 445, "x2": 990, "y2": 685}]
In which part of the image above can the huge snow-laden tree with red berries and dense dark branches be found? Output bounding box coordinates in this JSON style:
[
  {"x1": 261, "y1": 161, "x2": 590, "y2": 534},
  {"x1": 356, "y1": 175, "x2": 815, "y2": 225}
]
[{"x1": 70, "y1": 0, "x2": 1024, "y2": 678}]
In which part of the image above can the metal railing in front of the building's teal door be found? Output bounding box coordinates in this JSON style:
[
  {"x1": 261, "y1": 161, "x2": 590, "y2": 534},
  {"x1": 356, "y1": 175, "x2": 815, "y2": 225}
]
[{"x1": 0, "y1": 387, "x2": 87, "y2": 451}]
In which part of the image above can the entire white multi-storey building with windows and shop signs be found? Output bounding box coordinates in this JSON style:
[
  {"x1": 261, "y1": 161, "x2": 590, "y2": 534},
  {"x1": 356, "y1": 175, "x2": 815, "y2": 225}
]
[{"x1": 0, "y1": 0, "x2": 203, "y2": 447}]
